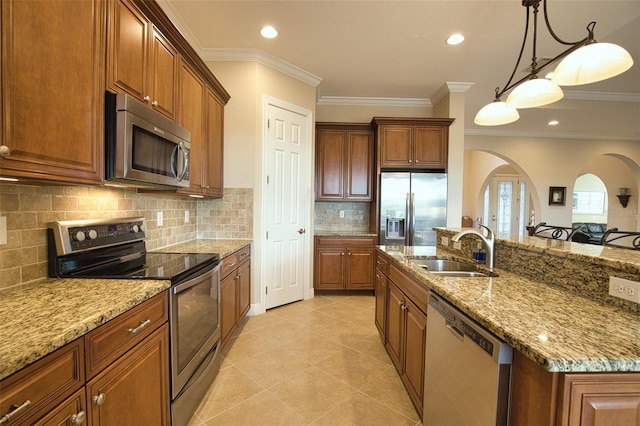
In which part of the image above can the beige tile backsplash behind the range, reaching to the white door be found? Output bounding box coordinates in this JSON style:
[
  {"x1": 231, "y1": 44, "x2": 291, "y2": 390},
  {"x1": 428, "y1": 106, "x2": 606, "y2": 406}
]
[{"x1": 0, "y1": 184, "x2": 253, "y2": 289}]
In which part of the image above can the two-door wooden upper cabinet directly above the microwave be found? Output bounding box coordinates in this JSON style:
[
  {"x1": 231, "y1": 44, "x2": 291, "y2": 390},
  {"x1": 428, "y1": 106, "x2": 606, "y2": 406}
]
[{"x1": 107, "y1": 0, "x2": 179, "y2": 119}]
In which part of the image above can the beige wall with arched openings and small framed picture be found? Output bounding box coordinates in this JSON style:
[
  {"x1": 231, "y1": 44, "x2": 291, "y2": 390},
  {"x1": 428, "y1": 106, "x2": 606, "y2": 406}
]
[{"x1": 463, "y1": 135, "x2": 640, "y2": 230}]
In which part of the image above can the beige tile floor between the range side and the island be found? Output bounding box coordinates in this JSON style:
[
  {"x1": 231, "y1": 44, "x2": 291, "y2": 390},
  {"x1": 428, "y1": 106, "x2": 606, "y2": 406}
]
[{"x1": 189, "y1": 295, "x2": 421, "y2": 426}]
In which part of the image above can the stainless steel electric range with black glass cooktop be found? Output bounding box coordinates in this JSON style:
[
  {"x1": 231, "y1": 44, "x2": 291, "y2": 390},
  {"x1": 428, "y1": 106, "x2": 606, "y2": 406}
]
[{"x1": 47, "y1": 217, "x2": 220, "y2": 425}]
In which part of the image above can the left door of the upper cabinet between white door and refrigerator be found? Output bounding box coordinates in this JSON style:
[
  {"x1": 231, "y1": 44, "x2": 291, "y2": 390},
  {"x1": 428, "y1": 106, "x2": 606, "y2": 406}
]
[{"x1": 316, "y1": 129, "x2": 346, "y2": 201}]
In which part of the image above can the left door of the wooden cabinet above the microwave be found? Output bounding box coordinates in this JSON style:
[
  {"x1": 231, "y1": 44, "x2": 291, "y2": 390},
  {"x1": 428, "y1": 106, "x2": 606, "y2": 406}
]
[{"x1": 107, "y1": 0, "x2": 150, "y2": 102}]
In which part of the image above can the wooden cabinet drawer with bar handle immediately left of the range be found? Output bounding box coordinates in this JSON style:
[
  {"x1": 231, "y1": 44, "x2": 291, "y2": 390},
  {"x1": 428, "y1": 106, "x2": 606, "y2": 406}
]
[{"x1": 85, "y1": 291, "x2": 169, "y2": 379}]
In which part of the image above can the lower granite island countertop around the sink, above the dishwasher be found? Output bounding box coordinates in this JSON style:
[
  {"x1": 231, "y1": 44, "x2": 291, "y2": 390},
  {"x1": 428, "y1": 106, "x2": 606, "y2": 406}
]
[{"x1": 379, "y1": 246, "x2": 640, "y2": 372}]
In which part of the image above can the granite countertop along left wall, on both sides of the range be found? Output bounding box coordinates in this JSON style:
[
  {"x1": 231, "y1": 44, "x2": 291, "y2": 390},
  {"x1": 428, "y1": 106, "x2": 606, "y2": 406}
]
[{"x1": 0, "y1": 239, "x2": 251, "y2": 379}]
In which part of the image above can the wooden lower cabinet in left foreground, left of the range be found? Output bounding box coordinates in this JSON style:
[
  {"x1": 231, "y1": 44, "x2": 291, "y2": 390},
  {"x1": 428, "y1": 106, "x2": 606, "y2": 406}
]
[{"x1": 0, "y1": 291, "x2": 171, "y2": 426}]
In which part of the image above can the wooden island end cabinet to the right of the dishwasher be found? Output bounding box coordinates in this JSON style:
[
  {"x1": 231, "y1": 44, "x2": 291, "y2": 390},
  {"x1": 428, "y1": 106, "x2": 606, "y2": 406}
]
[{"x1": 510, "y1": 352, "x2": 640, "y2": 426}]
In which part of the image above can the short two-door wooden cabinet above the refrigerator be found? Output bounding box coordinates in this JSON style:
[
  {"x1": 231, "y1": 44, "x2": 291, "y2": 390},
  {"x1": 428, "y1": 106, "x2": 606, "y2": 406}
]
[{"x1": 372, "y1": 117, "x2": 453, "y2": 170}]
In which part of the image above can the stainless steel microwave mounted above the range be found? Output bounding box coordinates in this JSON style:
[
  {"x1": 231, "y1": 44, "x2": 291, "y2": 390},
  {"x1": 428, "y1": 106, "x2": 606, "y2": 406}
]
[{"x1": 105, "y1": 92, "x2": 191, "y2": 188}]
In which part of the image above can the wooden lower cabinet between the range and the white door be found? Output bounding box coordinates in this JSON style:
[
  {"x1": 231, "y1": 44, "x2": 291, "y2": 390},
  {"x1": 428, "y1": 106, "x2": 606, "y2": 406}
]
[{"x1": 220, "y1": 246, "x2": 251, "y2": 346}]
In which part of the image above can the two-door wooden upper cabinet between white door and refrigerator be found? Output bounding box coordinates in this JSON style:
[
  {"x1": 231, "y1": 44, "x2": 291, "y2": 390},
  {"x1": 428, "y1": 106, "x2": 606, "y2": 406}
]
[{"x1": 316, "y1": 123, "x2": 373, "y2": 201}]
